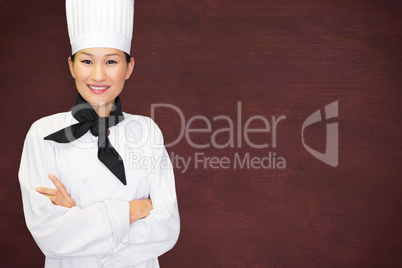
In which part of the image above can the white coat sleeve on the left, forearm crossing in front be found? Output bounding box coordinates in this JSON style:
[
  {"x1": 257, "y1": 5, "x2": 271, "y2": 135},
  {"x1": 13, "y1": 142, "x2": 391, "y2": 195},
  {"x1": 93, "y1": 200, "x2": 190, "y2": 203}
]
[{"x1": 18, "y1": 121, "x2": 129, "y2": 258}]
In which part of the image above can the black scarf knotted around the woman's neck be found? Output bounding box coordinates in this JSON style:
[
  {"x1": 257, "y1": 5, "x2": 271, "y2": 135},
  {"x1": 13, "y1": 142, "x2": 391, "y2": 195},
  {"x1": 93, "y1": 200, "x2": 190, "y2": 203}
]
[{"x1": 44, "y1": 94, "x2": 127, "y2": 185}]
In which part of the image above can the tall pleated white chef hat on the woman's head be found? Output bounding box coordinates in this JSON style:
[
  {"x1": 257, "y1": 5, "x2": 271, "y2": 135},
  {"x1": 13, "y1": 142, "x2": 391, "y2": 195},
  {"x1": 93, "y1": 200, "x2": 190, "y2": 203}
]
[{"x1": 66, "y1": 0, "x2": 134, "y2": 55}]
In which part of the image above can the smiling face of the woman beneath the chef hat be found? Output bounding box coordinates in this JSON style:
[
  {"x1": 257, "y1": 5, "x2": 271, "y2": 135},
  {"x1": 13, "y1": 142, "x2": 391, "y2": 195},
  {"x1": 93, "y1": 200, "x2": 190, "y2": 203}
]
[{"x1": 68, "y1": 48, "x2": 134, "y2": 117}]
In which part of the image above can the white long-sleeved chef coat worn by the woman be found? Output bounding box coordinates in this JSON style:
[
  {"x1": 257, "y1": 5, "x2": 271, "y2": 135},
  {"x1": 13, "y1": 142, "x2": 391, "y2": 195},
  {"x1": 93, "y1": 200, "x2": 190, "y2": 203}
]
[{"x1": 19, "y1": 112, "x2": 180, "y2": 268}]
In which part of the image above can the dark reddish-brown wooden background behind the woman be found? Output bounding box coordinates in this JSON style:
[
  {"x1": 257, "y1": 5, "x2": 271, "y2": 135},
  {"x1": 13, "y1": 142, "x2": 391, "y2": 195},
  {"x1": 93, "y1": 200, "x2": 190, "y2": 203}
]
[{"x1": 0, "y1": 0, "x2": 402, "y2": 268}]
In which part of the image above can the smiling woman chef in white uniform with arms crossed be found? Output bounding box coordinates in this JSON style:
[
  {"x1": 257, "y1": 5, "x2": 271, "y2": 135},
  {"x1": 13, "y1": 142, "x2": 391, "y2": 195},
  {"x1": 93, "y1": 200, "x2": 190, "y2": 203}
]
[{"x1": 19, "y1": 0, "x2": 180, "y2": 268}]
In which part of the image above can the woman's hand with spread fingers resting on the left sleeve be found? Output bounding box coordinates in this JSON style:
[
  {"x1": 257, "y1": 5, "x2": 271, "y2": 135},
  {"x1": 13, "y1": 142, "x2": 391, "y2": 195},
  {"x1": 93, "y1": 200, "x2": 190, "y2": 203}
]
[{"x1": 36, "y1": 174, "x2": 75, "y2": 208}]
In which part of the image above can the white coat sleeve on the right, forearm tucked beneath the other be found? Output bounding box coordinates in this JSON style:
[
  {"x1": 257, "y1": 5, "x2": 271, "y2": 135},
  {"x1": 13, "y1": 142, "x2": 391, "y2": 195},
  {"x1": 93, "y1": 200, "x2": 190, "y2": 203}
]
[{"x1": 114, "y1": 119, "x2": 180, "y2": 267}]
